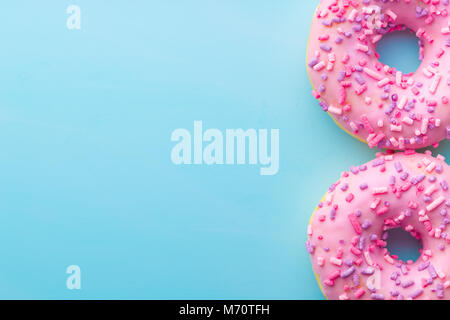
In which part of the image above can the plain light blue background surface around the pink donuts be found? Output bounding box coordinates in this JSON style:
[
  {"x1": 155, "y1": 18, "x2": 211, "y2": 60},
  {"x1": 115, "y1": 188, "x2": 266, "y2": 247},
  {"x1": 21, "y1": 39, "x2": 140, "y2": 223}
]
[{"x1": 0, "y1": 0, "x2": 436, "y2": 299}]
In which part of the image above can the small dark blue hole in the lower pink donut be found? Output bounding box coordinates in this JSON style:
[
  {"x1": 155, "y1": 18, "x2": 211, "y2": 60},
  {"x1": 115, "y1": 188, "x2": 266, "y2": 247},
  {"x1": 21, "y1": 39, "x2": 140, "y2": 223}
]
[{"x1": 386, "y1": 228, "x2": 422, "y2": 262}]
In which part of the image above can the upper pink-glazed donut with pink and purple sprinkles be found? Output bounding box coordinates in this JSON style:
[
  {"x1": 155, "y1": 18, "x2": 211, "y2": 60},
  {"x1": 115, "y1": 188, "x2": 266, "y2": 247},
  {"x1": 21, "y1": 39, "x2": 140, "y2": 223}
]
[{"x1": 307, "y1": 0, "x2": 450, "y2": 150}]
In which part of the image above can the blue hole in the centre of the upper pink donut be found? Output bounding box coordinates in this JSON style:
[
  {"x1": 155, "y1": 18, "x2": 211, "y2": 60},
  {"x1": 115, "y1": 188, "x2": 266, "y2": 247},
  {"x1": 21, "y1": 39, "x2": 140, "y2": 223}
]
[{"x1": 376, "y1": 29, "x2": 421, "y2": 74}]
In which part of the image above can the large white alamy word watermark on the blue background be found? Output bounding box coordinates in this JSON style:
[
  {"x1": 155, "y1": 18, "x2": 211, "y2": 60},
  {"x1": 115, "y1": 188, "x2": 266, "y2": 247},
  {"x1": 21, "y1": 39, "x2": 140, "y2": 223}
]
[{"x1": 171, "y1": 121, "x2": 280, "y2": 176}]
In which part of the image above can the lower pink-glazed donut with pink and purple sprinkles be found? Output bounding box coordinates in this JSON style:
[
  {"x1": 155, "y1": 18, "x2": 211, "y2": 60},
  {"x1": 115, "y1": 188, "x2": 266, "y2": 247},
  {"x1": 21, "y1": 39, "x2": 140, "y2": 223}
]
[{"x1": 306, "y1": 151, "x2": 450, "y2": 300}]
